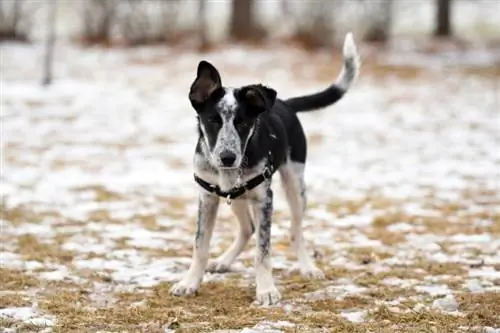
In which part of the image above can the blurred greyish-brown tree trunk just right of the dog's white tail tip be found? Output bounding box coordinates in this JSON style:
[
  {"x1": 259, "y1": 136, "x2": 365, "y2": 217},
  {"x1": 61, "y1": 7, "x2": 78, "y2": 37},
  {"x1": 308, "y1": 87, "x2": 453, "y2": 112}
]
[{"x1": 364, "y1": 0, "x2": 394, "y2": 43}]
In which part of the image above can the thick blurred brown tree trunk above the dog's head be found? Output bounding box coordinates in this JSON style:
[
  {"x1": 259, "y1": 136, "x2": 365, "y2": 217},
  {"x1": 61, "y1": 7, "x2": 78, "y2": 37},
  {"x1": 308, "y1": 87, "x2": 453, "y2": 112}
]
[{"x1": 230, "y1": 0, "x2": 257, "y2": 41}]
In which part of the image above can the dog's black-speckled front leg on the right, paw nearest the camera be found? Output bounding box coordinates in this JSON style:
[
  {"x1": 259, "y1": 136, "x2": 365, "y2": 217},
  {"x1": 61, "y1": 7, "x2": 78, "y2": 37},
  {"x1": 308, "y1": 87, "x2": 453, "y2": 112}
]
[{"x1": 253, "y1": 182, "x2": 281, "y2": 305}]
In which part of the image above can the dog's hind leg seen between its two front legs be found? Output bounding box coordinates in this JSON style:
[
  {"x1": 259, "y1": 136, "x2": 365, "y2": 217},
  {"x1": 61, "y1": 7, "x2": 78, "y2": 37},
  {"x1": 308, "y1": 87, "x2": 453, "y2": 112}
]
[{"x1": 207, "y1": 200, "x2": 255, "y2": 273}]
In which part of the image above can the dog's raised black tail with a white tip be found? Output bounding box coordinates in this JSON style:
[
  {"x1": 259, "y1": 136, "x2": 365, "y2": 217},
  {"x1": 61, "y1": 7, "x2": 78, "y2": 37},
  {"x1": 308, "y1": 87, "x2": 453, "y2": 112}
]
[{"x1": 285, "y1": 32, "x2": 360, "y2": 112}]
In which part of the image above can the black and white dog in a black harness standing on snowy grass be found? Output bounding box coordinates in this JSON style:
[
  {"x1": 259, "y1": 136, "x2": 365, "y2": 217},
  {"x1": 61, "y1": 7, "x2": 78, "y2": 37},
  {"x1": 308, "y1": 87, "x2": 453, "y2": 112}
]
[{"x1": 170, "y1": 33, "x2": 360, "y2": 305}]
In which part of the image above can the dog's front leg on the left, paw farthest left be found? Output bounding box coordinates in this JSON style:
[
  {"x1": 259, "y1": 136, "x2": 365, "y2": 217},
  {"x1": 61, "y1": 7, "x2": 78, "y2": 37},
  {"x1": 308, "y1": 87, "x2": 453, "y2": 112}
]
[{"x1": 170, "y1": 192, "x2": 219, "y2": 296}]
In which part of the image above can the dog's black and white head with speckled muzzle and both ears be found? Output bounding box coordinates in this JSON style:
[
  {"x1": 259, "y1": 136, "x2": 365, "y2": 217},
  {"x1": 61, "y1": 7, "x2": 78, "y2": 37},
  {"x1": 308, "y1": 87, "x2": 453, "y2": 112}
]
[{"x1": 189, "y1": 61, "x2": 276, "y2": 169}]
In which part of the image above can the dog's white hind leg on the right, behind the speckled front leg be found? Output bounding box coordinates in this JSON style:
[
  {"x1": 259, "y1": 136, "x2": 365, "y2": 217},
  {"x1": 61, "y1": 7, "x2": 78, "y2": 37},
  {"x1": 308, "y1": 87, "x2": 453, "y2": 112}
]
[{"x1": 280, "y1": 162, "x2": 324, "y2": 278}]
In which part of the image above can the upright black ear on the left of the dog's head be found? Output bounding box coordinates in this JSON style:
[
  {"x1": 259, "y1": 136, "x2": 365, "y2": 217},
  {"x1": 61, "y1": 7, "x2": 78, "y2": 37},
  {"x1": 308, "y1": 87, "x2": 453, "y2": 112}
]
[{"x1": 189, "y1": 60, "x2": 222, "y2": 109}]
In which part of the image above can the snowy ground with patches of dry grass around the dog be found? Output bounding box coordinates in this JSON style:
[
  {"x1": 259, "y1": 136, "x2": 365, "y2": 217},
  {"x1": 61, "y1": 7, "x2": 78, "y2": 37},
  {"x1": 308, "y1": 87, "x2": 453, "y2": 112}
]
[{"x1": 0, "y1": 39, "x2": 500, "y2": 333}]
